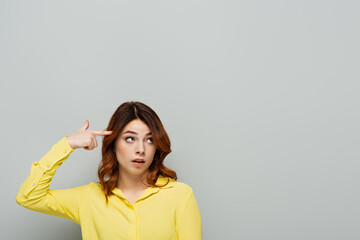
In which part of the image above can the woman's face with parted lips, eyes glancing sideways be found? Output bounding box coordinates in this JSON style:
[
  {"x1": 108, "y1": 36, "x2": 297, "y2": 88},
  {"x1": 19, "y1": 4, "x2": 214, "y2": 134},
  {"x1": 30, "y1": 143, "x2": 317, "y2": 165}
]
[{"x1": 115, "y1": 119, "x2": 156, "y2": 176}]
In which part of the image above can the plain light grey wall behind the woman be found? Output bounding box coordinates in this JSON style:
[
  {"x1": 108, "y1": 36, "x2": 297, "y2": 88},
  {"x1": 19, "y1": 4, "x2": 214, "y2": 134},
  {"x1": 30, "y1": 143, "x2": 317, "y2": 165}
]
[{"x1": 0, "y1": 0, "x2": 360, "y2": 240}]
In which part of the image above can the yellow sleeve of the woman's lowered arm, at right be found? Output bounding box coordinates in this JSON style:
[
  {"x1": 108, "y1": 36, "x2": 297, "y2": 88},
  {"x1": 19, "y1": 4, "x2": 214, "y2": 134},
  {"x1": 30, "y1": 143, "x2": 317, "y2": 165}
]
[{"x1": 176, "y1": 189, "x2": 202, "y2": 240}]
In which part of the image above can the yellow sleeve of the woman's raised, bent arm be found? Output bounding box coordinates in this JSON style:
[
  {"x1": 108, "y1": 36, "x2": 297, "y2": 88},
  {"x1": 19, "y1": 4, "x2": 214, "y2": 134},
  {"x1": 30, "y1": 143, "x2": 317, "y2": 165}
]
[{"x1": 16, "y1": 136, "x2": 89, "y2": 224}]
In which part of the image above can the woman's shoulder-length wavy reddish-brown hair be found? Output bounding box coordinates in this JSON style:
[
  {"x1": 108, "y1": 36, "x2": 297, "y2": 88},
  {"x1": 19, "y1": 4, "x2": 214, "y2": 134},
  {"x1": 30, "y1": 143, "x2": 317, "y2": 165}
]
[{"x1": 98, "y1": 101, "x2": 177, "y2": 203}]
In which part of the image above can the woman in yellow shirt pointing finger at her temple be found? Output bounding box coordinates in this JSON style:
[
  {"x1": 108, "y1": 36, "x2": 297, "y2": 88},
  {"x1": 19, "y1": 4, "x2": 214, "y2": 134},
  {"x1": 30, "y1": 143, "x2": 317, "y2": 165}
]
[{"x1": 16, "y1": 102, "x2": 202, "y2": 240}]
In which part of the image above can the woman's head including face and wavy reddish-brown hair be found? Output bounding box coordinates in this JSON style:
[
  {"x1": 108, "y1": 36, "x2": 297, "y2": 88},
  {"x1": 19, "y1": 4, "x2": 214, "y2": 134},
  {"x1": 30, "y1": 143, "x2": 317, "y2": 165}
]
[{"x1": 98, "y1": 101, "x2": 177, "y2": 201}]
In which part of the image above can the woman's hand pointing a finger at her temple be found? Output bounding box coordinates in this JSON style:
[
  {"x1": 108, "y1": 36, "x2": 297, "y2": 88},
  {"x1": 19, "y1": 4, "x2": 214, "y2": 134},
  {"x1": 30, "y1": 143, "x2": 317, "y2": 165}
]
[{"x1": 67, "y1": 120, "x2": 112, "y2": 150}]
